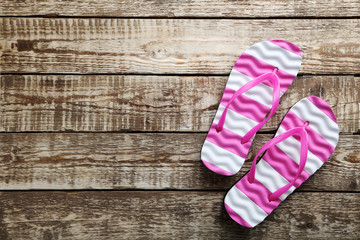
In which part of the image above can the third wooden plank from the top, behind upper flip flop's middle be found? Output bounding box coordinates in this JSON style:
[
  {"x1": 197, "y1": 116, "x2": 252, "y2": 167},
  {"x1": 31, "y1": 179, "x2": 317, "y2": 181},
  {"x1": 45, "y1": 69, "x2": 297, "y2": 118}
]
[{"x1": 0, "y1": 75, "x2": 360, "y2": 133}]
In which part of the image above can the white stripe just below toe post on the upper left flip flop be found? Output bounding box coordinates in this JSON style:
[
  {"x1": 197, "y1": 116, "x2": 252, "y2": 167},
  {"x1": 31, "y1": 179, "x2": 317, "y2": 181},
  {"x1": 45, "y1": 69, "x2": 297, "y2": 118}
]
[{"x1": 226, "y1": 69, "x2": 284, "y2": 108}]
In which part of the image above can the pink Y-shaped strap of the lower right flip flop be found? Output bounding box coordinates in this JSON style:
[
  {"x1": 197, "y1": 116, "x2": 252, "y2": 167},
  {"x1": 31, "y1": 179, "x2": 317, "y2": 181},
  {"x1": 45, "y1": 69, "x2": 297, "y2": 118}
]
[{"x1": 248, "y1": 122, "x2": 309, "y2": 201}]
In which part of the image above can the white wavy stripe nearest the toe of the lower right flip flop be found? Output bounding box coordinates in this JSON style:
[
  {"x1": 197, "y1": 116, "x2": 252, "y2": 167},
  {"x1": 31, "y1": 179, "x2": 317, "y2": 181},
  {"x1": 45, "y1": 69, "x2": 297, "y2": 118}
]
[{"x1": 290, "y1": 98, "x2": 339, "y2": 147}]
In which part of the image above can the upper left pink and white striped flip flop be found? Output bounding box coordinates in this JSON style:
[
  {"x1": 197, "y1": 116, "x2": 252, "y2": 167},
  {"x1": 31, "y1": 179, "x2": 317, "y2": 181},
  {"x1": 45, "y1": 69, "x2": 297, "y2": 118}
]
[{"x1": 201, "y1": 40, "x2": 302, "y2": 176}]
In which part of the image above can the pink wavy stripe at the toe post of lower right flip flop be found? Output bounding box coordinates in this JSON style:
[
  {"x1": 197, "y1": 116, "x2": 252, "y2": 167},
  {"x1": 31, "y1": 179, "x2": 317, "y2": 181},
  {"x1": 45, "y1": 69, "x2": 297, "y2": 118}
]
[{"x1": 281, "y1": 110, "x2": 335, "y2": 162}]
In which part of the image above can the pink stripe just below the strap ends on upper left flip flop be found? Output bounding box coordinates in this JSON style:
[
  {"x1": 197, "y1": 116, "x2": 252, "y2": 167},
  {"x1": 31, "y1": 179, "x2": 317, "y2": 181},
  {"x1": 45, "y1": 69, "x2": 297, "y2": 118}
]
[{"x1": 206, "y1": 124, "x2": 252, "y2": 158}]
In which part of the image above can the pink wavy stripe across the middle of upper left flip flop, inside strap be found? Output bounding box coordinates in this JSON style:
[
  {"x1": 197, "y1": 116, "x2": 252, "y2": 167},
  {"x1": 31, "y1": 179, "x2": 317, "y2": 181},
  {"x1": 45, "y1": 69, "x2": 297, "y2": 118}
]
[{"x1": 220, "y1": 88, "x2": 270, "y2": 122}]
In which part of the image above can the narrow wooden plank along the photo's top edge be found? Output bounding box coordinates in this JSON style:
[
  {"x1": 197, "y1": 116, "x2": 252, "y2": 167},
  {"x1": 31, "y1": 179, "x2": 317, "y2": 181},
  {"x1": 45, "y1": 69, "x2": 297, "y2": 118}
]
[{"x1": 0, "y1": 0, "x2": 360, "y2": 18}]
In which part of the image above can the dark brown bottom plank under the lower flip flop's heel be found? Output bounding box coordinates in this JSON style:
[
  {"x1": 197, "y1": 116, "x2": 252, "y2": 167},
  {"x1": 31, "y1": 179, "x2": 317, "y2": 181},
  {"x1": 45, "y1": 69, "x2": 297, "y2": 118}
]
[{"x1": 0, "y1": 191, "x2": 360, "y2": 239}]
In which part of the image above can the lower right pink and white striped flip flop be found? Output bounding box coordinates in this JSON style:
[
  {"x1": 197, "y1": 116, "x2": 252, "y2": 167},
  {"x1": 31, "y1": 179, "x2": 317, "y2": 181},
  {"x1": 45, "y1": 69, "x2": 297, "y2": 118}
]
[{"x1": 224, "y1": 96, "x2": 339, "y2": 228}]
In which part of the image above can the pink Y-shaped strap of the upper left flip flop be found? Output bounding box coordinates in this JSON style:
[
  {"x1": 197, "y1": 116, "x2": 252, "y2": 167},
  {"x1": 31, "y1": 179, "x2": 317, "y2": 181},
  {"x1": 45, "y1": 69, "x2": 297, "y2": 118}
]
[{"x1": 215, "y1": 68, "x2": 280, "y2": 144}]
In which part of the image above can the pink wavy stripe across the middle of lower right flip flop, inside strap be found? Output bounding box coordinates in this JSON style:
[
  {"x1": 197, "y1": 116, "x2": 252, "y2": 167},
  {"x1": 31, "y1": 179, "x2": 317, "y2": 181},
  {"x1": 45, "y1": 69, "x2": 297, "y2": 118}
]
[{"x1": 262, "y1": 145, "x2": 311, "y2": 188}]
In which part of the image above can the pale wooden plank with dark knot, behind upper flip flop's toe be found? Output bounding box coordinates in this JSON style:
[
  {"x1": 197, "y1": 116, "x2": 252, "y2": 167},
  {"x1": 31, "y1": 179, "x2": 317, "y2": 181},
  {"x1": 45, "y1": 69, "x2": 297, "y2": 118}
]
[{"x1": 0, "y1": 18, "x2": 360, "y2": 74}]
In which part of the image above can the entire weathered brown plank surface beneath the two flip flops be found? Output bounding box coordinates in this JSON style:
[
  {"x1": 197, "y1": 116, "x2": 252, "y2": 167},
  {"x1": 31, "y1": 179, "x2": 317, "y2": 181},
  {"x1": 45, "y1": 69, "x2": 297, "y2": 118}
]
[{"x1": 0, "y1": 0, "x2": 360, "y2": 239}]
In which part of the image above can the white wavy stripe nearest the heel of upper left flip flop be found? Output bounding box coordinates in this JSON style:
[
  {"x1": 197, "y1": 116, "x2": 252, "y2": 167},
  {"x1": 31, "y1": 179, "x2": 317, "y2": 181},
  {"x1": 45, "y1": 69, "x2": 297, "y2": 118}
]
[{"x1": 201, "y1": 140, "x2": 245, "y2": 174}]
